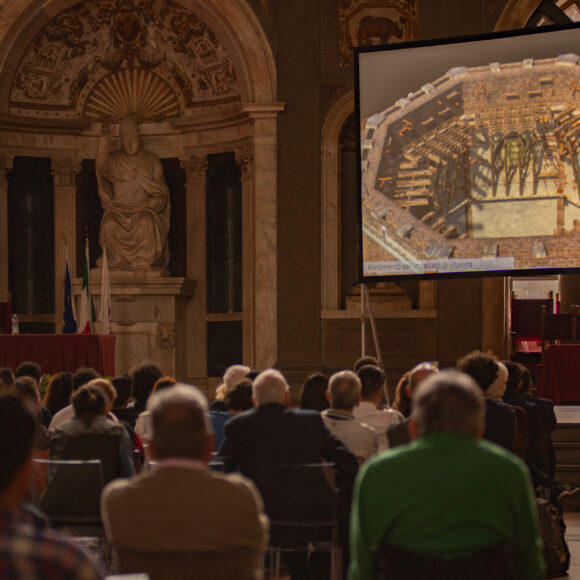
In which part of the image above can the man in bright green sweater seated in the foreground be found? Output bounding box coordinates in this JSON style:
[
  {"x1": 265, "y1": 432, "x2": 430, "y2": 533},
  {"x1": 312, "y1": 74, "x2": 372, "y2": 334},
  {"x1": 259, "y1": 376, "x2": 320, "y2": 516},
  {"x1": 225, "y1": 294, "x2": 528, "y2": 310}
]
[{"x1": 349, "y1": 371, "x2": 545, "y2": 580}]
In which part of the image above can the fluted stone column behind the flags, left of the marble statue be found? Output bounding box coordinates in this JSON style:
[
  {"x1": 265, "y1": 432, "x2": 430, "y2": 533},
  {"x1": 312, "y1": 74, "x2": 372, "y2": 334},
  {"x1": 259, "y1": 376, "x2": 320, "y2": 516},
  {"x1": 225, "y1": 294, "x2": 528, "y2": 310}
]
[{"x1": 52, "y1": 158, "x2": 81, "y2": 334}]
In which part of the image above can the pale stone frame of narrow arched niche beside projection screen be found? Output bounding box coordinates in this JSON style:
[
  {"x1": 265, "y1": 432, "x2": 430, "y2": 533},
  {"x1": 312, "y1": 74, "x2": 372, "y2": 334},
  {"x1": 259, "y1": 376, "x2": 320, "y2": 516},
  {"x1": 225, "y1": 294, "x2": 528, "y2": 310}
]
[{"x1": 320, "y1": 91, "x2": 354, "y2": 310}]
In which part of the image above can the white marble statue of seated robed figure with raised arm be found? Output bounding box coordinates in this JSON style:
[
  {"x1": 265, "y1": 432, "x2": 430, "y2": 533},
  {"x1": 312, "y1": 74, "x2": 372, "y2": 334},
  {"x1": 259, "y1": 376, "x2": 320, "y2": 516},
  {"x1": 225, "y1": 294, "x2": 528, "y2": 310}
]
[{"x1": 95, "y1": 115, "x2": 170, "y2": 271}]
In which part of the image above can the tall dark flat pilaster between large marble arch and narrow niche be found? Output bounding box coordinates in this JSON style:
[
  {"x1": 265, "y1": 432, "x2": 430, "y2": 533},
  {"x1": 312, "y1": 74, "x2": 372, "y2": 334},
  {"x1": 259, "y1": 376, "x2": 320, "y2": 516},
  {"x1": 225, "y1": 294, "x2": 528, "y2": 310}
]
[{"x1": 276, "y1": 0, "x2": 321, "y2": 366}]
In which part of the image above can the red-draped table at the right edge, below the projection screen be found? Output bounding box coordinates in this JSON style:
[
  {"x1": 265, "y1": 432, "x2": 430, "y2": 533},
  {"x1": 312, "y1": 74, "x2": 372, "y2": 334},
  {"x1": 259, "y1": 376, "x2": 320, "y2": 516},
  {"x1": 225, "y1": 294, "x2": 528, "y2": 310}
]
[{"x1": 538, "y1": 344, "x2": 580, "y2": 405}]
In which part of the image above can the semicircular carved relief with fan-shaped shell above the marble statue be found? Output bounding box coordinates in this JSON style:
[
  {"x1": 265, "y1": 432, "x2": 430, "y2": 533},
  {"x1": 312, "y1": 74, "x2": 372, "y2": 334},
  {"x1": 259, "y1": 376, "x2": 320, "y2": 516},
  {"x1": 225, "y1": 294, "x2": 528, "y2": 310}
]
[{"x1": 10, "y1": 0, "x2": 240, "y2": 121}]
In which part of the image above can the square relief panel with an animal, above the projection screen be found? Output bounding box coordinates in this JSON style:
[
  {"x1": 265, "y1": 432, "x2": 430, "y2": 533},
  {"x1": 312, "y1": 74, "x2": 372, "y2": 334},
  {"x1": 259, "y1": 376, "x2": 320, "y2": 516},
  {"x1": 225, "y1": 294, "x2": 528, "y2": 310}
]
[{"x1": 338, "y1": 0, "x2": 419, "y2": 66}]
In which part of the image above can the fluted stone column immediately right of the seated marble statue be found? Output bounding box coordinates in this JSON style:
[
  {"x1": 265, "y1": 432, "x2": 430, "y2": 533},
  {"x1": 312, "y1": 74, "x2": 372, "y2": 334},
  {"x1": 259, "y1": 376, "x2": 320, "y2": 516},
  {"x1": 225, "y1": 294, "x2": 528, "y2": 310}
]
[{"x1": 181, "y1": 155, "x2": 207, "y2": 380}]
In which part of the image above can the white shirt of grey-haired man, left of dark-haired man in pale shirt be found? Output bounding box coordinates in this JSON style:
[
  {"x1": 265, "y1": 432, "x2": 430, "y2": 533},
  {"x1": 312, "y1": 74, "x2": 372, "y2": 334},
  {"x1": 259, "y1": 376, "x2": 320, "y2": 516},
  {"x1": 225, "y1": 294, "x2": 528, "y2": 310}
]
[{"x1": 321, "y1": 409, "x2": 378, "y2": 463}]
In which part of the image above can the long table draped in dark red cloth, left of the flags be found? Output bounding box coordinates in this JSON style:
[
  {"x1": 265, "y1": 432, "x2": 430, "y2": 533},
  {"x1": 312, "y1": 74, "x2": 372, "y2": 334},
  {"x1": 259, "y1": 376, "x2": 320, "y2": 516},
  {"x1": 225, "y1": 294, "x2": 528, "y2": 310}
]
[{"x1": 0, "y1": 334, "x2": 115, "y2": 376}]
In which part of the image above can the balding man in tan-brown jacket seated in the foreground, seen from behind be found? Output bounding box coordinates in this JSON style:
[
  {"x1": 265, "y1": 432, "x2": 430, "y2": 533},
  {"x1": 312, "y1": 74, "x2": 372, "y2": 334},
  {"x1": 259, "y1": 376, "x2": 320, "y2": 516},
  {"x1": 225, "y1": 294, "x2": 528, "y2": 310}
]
[{"x1": 101, "y1": 385, "x2": 268, "y2": 580}]
